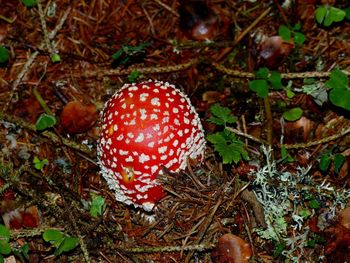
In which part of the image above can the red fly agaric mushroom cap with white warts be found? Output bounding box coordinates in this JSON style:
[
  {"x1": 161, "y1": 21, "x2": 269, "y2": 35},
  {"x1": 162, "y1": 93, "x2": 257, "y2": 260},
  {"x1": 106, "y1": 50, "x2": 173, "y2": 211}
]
[{"x1": 97, "y1": 80, "x2": 205, "y2": 211}]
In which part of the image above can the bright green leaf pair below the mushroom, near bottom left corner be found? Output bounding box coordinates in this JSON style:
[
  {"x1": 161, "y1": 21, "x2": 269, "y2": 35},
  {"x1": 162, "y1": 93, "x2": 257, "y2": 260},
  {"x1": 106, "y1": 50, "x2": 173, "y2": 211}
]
[{"x1": 43, "y1": 229, "x2": 79, "y2": 256}]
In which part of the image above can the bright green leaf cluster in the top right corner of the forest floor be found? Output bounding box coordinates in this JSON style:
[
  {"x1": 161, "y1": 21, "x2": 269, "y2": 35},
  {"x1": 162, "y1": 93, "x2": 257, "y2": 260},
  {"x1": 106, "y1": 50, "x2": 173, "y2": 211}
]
[{"x1": 315, "y1": 5, "x2": 346, "y2": 27}]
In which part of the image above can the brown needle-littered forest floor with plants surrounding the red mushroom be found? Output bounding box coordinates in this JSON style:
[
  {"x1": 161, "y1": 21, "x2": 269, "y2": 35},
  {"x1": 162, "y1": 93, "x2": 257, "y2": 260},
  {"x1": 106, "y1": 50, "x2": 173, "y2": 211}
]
[{"x1": 0, "y1": 0, "x2": 350, "y2": 263}]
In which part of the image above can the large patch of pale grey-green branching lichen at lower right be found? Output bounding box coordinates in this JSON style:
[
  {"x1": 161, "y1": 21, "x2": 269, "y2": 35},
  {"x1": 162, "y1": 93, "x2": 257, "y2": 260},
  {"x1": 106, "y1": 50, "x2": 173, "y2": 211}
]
[{"x1": 251, "y1": 146, "x2": 350, "y2": 262}]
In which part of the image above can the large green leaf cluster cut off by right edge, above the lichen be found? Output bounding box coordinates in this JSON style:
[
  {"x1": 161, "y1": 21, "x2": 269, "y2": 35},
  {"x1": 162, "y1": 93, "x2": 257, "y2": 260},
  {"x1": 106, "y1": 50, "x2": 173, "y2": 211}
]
[{"x1": 325, "y1": 69, "x2": 350, "y2": 111}]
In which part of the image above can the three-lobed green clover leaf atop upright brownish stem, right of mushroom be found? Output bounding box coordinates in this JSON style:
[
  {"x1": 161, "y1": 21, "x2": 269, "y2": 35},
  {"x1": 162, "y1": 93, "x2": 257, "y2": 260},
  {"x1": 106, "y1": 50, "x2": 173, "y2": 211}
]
[{"x1": 249, "y1": 67, "x2": 283, "y2": 98}]
